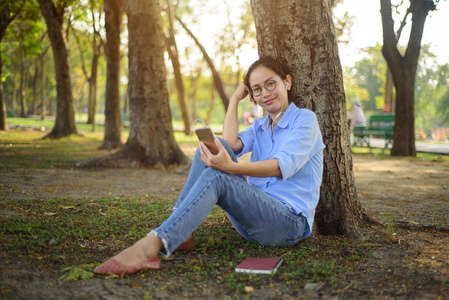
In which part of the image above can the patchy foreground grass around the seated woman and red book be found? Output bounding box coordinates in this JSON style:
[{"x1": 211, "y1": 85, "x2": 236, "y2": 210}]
[{"x1": 0, "y1": 197, "x2": 370, "y2": 295}]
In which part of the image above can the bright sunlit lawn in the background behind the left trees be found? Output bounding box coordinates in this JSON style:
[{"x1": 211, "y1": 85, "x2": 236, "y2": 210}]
[{"x1": 0, "y1": 118, "x2": 202, "y2": 169}]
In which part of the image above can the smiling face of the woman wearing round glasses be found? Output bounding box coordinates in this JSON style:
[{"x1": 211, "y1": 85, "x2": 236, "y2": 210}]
[{"x1": 249, "y1": 66, "x2": 292, "y2": 120}]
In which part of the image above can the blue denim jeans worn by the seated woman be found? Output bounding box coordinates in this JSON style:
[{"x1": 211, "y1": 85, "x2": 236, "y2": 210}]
[{"x1": 151, "y1": 139, "x2": 307, "y2": 256}]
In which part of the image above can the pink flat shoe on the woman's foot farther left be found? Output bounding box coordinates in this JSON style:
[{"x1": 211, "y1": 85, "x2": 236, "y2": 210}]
[{"x1": 94, "y1": 256, "x2": 161, "y2": 276}]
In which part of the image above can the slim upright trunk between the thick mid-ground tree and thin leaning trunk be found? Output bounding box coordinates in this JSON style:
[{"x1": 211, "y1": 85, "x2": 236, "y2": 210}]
[{"x1": 166, "y1": 0, "x2": 193, "y2": 135}]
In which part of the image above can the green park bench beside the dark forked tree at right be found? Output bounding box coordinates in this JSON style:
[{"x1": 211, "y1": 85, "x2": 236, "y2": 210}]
[{"x1": 352, "y1": 114, "x2": 394, "y2": 150}]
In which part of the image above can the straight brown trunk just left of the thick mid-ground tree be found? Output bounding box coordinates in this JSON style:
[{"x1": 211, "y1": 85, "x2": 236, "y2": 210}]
[{"x1": 100, "y1": 0, "x2": 123, "y2": 149}]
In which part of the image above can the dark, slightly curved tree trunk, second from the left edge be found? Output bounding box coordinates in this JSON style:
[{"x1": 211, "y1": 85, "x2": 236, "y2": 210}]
[{"x1": 39, "y1": 0, "x2": 77, "y2": 138}]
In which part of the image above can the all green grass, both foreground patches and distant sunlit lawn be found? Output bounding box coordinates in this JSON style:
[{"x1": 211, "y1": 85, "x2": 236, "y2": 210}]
[{"x1": 0, "y1": 118, "x2": 440, "y2": 297}]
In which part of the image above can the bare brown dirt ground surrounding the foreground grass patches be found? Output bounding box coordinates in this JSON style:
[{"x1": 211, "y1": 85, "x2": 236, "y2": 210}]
[{"x1": 0, "y1": 155, "x2": 449, "y2": 299}]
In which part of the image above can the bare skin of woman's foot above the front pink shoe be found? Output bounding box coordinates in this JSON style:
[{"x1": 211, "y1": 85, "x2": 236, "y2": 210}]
[{"x1": 114, "y1": 233, "x2": 163, "y2": 266}]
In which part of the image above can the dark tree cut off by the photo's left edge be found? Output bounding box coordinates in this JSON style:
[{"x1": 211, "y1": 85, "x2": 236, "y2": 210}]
[{"x1": 0, "y1": 0, "x2": 25, "y2": 130}]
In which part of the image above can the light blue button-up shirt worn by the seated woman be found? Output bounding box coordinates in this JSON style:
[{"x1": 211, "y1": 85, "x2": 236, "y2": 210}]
[{"x1": 236, "y1": 103, "x2": 324, "y2": 237}]
